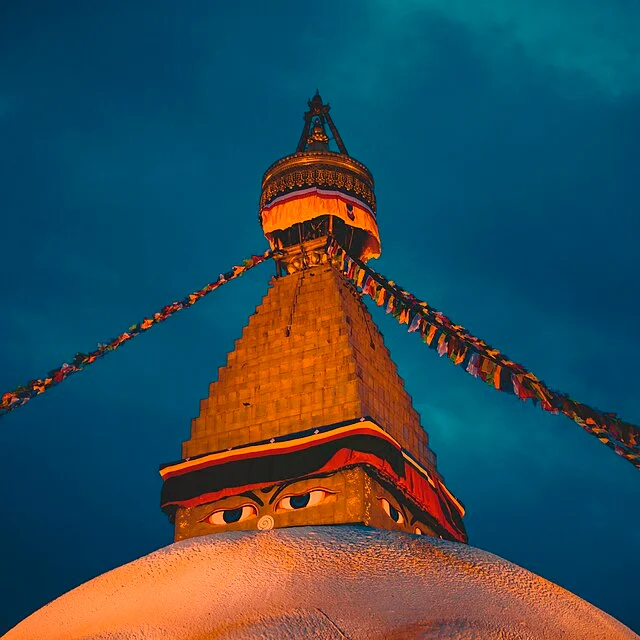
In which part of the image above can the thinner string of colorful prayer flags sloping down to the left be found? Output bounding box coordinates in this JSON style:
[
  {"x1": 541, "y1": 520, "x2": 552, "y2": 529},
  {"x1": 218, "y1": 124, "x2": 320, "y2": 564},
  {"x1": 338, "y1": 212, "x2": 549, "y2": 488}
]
[{"x1": 0, "y1": 251, "x2": 273, "y2": 417}]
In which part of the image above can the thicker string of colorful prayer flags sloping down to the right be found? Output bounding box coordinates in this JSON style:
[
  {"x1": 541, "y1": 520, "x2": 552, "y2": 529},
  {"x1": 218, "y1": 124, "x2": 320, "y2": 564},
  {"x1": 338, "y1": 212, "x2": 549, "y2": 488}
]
[{"x1": 327, "y1": 238, "x2": 640, "y2": 469}]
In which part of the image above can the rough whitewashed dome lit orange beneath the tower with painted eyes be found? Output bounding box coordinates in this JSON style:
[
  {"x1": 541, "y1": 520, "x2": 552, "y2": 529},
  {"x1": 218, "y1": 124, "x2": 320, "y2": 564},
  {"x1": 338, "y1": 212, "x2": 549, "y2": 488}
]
[{"x1": 5, "y1": 526, "x2": 638, "y2": 640}]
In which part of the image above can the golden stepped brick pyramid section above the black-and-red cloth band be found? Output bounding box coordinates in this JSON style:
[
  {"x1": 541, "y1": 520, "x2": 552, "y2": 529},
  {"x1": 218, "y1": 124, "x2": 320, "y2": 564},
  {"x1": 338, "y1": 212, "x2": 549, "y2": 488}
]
[{"x1": 182, "y1": 264, "x2": 435, "y2": 470}]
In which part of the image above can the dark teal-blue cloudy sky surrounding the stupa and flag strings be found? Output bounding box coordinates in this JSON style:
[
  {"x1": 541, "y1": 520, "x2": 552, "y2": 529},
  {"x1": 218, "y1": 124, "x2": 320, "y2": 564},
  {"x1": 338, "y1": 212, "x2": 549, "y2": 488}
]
[{"x1": 0, "y1": 0, "x2": 640, "y2": 631}]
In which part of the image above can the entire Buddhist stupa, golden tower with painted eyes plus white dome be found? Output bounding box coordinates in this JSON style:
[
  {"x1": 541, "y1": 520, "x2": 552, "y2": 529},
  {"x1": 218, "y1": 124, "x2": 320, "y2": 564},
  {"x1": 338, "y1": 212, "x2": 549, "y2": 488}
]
[{"x1": 4, "y1": 93, "x2": 638, "y2": 640}]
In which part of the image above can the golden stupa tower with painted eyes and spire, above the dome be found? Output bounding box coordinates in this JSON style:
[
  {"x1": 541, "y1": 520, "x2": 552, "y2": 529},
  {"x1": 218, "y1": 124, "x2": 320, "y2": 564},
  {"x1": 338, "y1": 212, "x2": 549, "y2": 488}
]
[{"x1": 161, "y1": 93, "x2": 466, "y2": 542}]
